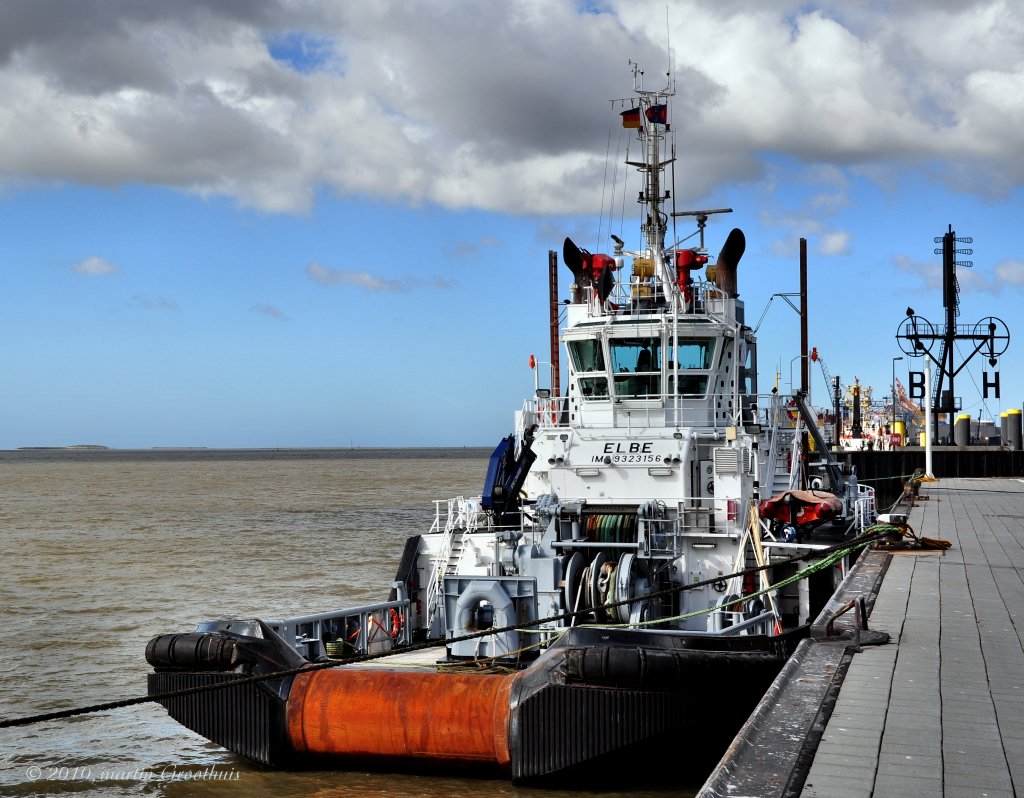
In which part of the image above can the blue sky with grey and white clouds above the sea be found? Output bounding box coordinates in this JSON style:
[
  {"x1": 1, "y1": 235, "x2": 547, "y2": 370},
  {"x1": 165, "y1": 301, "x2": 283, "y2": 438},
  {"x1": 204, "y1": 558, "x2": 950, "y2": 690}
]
[{"x1": 0, "y1": 0, "x2": 1024, "y2": 449}]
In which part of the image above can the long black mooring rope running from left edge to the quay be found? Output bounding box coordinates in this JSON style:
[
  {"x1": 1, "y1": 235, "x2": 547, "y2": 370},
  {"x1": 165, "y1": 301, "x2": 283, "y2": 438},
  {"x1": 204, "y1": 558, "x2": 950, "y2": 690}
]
[{"x1": 0, "y1": 524, "x2": 902, "y2": 728}]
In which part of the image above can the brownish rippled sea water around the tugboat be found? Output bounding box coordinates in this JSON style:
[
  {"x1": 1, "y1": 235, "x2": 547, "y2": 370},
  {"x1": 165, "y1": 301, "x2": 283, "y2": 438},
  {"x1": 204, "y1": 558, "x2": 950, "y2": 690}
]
[{"x1": 0, "y1": 450, "x2": 700, "y2": 798}]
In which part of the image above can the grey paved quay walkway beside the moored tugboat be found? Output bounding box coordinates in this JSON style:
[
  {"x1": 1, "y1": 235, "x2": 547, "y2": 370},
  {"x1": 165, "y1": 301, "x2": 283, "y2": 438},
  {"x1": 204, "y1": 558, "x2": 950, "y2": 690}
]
[{"x1": 699, "y1": 478, "x2": 1024, "y2": 798}]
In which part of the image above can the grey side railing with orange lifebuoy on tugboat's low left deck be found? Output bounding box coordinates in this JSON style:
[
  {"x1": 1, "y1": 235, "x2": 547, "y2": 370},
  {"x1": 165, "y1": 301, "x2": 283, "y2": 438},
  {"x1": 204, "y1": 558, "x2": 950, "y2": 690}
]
[{"x1": 267, "y1": 594, "x2": 412, "y2": 661}]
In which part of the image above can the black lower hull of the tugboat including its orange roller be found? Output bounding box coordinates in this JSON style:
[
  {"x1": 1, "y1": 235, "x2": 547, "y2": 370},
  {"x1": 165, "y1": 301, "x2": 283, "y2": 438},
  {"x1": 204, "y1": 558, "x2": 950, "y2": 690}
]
[{"x1": 150, "y1": 628, "x2": 803, "y2": 782}]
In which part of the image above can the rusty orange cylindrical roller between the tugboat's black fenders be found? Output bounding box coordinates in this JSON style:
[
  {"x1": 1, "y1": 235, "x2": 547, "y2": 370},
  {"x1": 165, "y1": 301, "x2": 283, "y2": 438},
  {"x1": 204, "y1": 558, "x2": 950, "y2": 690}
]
[{"x1": 287, "y1": 669, "x2": 518, "y2": 769}]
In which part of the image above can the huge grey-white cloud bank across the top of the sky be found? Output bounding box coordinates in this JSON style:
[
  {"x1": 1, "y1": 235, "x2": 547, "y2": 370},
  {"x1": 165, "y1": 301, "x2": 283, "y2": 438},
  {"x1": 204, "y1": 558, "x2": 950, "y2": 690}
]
[{"x1": 0, "y1": 0, "x2": 1024, "y2": 212}]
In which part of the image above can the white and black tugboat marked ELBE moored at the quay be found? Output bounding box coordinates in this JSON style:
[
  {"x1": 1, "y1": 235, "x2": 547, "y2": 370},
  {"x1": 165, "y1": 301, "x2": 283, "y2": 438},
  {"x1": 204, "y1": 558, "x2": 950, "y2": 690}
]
[{"x1": 146, "y1": 68, "x2": 873, "y2": 782}]
